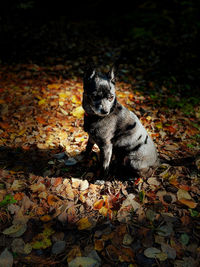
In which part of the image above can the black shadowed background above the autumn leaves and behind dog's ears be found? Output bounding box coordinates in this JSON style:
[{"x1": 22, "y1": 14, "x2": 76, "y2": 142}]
[{"x1": 0, "y1": 0, "x2": 200, "y2": 98}]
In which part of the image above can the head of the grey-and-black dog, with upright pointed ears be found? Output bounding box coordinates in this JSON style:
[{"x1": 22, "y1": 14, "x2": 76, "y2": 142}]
[{"x1": 83, "y1": 68, "x2": 116, "y2": 116}]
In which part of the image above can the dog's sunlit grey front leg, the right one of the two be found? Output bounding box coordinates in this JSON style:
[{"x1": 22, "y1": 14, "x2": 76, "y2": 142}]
[{"x1": 100, "y1": 143, "x2": 112, "y2": 177}]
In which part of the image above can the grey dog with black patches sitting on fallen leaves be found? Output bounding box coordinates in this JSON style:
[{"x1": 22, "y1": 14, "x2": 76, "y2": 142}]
[{"x1": 82, "y1": 64, "x2": 159, "y2": 178}]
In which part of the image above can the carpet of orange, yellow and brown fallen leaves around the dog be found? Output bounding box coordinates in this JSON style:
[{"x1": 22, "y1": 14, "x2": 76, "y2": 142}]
[{"x1": 0, "y1": 59, "x2": 200, "y2": 266}]
